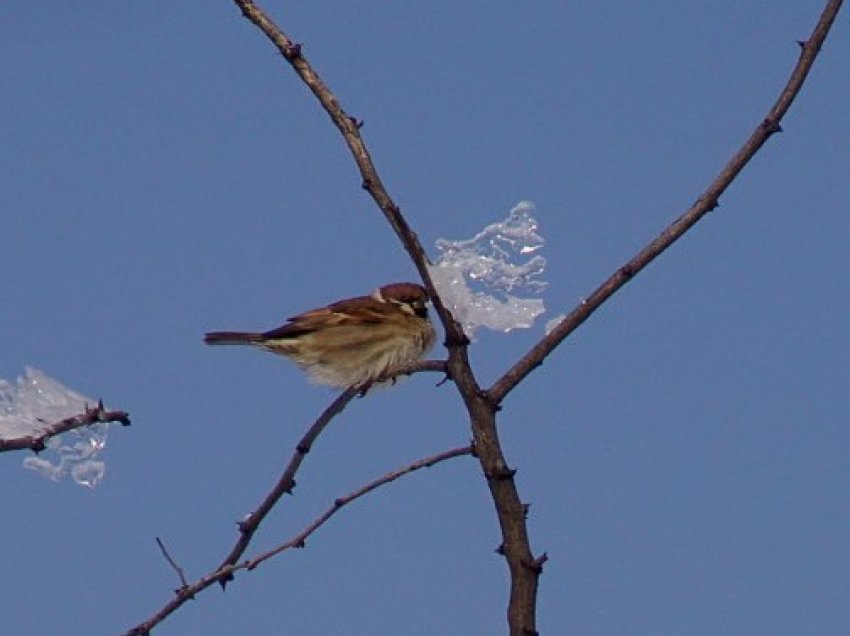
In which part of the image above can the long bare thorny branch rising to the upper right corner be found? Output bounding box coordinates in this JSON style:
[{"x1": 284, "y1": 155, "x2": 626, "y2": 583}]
[{"x1": 487, "y1": 0, "x2": 842, "y2": 405}]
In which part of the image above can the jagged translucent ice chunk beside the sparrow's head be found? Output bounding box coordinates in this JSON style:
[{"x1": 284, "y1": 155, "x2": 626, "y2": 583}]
[{"x1": 429, "y1": 201, "x2": 546, "y2": 338}]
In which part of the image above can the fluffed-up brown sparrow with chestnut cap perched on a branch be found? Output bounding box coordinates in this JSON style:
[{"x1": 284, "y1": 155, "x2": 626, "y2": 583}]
[{"x1": 204, "y1": 283, "x2": 436, "y2": 393}]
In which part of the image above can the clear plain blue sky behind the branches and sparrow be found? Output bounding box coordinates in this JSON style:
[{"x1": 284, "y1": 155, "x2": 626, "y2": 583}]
[{"x1": 0, "y1": 0, "x2": 850, "y2": 636}]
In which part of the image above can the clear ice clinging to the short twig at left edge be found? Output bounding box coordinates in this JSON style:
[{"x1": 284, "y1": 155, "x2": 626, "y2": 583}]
[{"x1": 0, "y1": 367, "x2": 109, "y2": 488}]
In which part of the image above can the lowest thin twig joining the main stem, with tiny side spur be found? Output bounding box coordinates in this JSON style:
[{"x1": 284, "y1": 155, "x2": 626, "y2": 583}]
[{"x1": 121, "y1": 444, "x2": 473, "y2": 636}]
